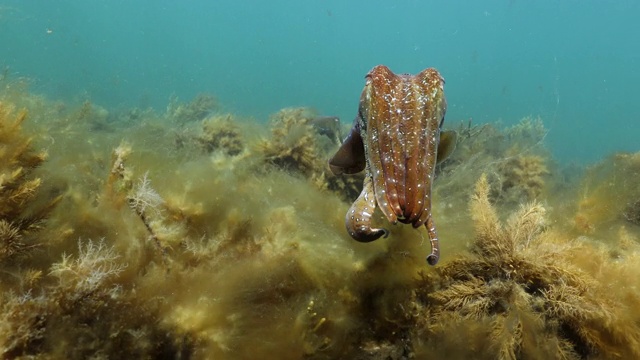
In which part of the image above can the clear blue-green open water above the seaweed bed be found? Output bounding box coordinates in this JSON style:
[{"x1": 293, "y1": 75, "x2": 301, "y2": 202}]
[{"x1": 0, "y1": 0, "x2": 640, "y2": 163}]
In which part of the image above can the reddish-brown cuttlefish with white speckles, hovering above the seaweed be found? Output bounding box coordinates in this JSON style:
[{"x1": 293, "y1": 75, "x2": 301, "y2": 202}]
[{"x1": 329, "y1": 65, "x2": 456, "y2": 265}]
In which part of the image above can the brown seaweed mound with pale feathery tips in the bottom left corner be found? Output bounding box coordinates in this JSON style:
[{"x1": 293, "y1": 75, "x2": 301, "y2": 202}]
[{"x1": 0, "y1": 240, "x2": 193, "y2": 359}]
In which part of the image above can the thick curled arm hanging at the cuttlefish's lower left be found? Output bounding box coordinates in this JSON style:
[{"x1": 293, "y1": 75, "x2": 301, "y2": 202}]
[{"x1": 345, "y1": 169, "x2": 389, "y2": 242}]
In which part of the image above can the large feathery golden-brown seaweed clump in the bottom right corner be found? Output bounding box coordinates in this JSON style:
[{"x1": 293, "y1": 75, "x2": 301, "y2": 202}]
[{"x1": 417, "y1": 176, "x2": 640, "y2": 359}]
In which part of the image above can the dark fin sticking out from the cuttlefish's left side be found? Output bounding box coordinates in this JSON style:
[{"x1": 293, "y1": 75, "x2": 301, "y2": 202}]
[{"x1": 329, "y1": 125, "x2": 366, "y2": 175}]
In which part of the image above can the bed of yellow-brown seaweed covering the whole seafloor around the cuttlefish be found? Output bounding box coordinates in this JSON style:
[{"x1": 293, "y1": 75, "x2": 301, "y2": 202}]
[{"x1": 0, "y1": 74, "x2": 640, "y2": 359}]
